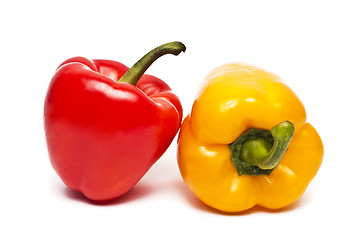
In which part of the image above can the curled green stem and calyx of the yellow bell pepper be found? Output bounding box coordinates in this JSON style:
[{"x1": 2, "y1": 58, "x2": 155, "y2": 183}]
[{"x1": 229, "y1": 121, "x2": 295, "y2": 175}]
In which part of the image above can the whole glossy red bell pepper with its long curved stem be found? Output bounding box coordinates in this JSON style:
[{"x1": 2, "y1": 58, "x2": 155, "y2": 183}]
[{"x1": 44, "y1": 42, "x2": 185, "y2": 201}]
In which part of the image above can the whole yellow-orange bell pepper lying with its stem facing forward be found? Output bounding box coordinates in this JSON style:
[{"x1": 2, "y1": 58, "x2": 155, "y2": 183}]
[{"x1": 178, "y1": 63, "x2": 324, "y2": 212}]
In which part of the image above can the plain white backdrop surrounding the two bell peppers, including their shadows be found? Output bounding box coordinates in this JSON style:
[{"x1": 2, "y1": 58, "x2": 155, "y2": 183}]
[{"x1": 0, "y1": 0, "x2": 360, "y2": 239}]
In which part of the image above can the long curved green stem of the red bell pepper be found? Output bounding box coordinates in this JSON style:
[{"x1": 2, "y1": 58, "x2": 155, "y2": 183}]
[{"x1": 118, "y1": 42, "x2": 186, "y2": 86}]
